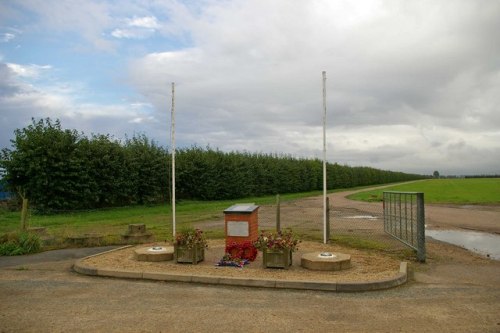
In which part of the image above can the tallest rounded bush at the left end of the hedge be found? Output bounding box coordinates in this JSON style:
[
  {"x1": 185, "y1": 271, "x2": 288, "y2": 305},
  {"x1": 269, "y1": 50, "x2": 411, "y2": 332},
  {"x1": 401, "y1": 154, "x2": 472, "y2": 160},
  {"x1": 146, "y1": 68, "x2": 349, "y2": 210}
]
[{"x1": 1, "y1": 119, "x2": 89, "y2": 210}]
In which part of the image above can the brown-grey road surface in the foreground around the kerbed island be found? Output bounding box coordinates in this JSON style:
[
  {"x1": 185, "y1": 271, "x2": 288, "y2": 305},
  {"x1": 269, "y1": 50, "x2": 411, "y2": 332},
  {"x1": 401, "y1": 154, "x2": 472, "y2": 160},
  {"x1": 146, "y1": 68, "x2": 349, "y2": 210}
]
[{"x1": 0, "y1": 245, "x2": 500, "y2": 332}]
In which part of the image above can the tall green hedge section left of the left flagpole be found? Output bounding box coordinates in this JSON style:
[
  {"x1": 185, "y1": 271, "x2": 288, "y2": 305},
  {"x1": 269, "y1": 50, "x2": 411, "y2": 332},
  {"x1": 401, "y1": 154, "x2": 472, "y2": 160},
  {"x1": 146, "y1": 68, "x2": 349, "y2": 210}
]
[{"x1": 0, "y1": 118, "x2": 169, "y2": 212}]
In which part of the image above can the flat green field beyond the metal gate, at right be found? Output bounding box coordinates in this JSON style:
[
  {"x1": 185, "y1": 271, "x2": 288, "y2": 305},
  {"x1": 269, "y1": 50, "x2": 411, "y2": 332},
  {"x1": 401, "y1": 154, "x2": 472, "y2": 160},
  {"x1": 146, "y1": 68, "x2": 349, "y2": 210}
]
[{"x1": 348, "y1": 178, "x2": 500, "y2": 205}]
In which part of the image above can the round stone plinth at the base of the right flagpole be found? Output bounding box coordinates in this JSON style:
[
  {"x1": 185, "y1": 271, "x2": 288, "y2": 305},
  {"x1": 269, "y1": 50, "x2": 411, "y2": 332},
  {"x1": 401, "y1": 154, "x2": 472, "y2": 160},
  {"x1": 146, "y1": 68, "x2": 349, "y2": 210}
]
[{"x1": 300, "y1": 252, "x2": 351, "y2": 271}]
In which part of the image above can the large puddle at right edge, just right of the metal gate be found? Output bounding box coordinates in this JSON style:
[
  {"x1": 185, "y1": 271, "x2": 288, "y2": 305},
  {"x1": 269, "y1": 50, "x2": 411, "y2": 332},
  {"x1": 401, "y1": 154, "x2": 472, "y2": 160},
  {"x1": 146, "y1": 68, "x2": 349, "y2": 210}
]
[{"x1": 425, "y1": 230, "x2": 500, "y2": 260}]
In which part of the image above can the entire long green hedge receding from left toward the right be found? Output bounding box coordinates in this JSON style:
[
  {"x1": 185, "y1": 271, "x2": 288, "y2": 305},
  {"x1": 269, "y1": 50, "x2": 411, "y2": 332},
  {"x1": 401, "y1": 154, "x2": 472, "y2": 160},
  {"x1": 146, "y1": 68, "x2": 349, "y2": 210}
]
[{"x1": 0, "y1": 118, "x2": 424, "y2": 213}]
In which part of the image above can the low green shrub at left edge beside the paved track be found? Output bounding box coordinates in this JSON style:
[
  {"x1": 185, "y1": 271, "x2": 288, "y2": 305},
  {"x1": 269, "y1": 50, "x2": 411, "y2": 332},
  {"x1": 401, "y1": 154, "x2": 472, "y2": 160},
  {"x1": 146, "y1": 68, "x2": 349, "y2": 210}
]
[{"x1": 0, "y1": 231, "x2": 42, "y2": 256}]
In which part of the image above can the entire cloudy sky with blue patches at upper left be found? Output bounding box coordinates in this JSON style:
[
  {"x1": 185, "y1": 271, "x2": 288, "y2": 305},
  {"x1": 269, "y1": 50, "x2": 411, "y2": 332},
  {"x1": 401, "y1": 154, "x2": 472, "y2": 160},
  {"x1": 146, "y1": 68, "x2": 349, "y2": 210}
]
[{"x1": 0, "y1": 0, "x2": 500, "y2": 175}]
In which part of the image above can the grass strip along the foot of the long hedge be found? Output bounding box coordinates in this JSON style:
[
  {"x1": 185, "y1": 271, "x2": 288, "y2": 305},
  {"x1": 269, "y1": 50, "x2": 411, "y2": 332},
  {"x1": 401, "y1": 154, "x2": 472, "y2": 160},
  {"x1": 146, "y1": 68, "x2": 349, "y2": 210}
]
[{"x1": 0, "y1": 191, "x2": 336, "y2": 248}]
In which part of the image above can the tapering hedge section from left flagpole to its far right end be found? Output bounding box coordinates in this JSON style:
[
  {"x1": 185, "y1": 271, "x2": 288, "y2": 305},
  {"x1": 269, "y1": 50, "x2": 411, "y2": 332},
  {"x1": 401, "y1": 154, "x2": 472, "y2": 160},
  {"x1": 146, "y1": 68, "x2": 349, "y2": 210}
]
[{"x1": 176, "y1": 146, "x2": 424, "y2": 200}]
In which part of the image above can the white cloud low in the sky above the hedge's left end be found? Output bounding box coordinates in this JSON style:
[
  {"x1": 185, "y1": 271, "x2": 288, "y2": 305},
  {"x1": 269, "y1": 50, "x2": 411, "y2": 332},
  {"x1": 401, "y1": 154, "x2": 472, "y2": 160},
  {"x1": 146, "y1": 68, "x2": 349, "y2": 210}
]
[{"x1": 0, "y1": 63, "x2": 155, "y2": 147}]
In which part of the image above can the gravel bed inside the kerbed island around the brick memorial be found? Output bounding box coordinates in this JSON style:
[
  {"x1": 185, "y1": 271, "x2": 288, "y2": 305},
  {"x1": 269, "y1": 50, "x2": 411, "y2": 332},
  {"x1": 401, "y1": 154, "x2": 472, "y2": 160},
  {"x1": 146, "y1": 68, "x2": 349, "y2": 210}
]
[{"x1": 84, "y1": 240, "x2": 400, "y2": 282}]
